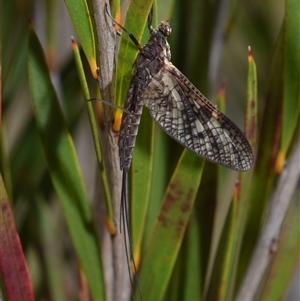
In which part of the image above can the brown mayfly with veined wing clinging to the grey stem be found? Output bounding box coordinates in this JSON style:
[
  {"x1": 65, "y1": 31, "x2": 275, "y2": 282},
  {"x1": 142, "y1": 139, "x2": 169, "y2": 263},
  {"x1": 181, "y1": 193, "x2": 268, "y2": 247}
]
[{"x1": 105, "y1": 2, "x2": 253, "y2": 298}]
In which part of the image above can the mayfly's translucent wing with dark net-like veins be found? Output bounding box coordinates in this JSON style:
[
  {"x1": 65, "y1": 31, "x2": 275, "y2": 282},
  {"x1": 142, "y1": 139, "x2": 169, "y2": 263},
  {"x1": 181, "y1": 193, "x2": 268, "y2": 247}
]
[{"x1": 143, "y1": 59, "x2": 253, "y2": 171}]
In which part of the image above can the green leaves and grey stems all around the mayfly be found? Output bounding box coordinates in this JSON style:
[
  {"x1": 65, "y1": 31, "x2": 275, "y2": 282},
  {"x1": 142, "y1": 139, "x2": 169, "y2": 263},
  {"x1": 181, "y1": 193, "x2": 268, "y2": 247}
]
[{"x1": 0, "y1": 0, "x2": 300, "y2": 301}]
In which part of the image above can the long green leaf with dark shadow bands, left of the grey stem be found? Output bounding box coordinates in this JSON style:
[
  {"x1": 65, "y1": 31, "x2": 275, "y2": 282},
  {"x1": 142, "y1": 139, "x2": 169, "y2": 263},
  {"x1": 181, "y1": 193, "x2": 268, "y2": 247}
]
[{"x1": 28, "y1": 25, "x2": 104, "y2": 300}]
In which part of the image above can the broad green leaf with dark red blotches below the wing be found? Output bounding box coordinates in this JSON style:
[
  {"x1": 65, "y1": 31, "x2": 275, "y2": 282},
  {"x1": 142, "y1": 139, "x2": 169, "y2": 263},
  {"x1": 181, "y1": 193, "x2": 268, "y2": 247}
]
[{"x1": 135, "y1": 150, "x2": 203, "y2": 301}]
